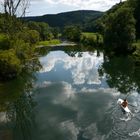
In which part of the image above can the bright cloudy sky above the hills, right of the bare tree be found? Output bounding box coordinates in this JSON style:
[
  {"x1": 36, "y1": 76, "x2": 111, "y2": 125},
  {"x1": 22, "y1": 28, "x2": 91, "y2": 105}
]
[{"x1": 26, "y1": 0, "x2": 124, "y2": 16}]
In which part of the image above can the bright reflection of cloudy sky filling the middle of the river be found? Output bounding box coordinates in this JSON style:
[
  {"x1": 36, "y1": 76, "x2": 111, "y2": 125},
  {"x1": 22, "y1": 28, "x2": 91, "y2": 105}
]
[{"x1": 35, "y1": 51, "x2": 126, "y2": 140}]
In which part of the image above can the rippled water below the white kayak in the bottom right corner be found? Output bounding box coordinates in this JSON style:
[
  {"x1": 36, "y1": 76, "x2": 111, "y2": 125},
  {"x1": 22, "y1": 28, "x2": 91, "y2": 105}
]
[{"x1": 106, "y1": 98, "x2": 140, "y2": 140}]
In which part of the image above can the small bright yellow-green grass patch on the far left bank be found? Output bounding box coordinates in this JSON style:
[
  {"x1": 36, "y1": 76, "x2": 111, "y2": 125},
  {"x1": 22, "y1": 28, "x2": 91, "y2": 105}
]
[{"x1": 39, "y1": 39, "x2": 61, "y2": 46}]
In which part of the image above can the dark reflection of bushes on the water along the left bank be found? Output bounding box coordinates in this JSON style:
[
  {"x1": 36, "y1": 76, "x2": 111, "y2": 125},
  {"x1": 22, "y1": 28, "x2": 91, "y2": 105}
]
[{"x1": 0, "y1": 73, "x2": 36, "y2": 140}]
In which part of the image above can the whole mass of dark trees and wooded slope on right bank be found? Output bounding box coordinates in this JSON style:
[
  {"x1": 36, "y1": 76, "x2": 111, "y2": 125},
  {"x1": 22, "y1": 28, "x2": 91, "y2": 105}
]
[{"x1": 96, "y1": 0, "x2": 140, "y2": 54}]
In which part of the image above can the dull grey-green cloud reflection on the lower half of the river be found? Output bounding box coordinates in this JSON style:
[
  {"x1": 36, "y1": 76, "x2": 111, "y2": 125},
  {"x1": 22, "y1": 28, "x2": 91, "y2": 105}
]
[{"x1": 34, "y1": 81, "x2": 117, "y2": 140}]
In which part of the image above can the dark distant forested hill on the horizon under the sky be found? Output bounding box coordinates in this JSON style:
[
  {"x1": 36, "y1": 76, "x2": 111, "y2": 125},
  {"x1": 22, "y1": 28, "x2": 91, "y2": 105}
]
[{"x1": 24, "y1": 10, "x2": 103, "y2": 28}]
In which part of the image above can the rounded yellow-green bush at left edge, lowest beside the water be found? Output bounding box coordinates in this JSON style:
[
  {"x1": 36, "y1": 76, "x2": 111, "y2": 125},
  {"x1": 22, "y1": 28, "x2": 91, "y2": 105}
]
[{"x1": 0, "y1": 49, "x2": 21, "y2": 79}]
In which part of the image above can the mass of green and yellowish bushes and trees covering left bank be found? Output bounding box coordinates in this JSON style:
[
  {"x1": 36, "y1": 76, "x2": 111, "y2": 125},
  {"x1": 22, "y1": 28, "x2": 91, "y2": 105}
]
[{"x1": 0, "y1": 14, "x2": 54, "y2": 80}]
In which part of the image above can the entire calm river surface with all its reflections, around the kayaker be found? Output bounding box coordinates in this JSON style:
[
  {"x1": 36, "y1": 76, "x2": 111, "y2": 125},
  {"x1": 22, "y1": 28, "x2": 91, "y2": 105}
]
[{"x1": 0, "y1": 48, "x2": 140, "y2": 140}]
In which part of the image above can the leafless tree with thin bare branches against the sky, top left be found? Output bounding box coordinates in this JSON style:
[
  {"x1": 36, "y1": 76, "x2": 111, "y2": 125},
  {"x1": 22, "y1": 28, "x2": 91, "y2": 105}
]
[{"x1": 2, "y1": 0, "x2": 29, "y2": 16}]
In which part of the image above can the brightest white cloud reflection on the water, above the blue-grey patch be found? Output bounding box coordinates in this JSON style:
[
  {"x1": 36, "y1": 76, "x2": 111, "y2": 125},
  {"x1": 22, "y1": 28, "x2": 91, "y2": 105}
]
[{"x1": 40, "y1": 52, "x2": 103, "y2": 85}]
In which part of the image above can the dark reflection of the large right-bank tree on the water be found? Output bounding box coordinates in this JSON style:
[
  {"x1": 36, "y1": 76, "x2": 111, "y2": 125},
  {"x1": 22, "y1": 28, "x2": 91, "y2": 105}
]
[{"x1": 98, "y1": 55, "x2": 140, "y2": 94}]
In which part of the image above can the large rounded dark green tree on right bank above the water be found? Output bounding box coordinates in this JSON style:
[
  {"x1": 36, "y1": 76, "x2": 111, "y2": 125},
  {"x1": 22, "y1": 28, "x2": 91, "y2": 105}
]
[{"x1": 104, "y1": 7, "x2": 135, "y2": 53}]
